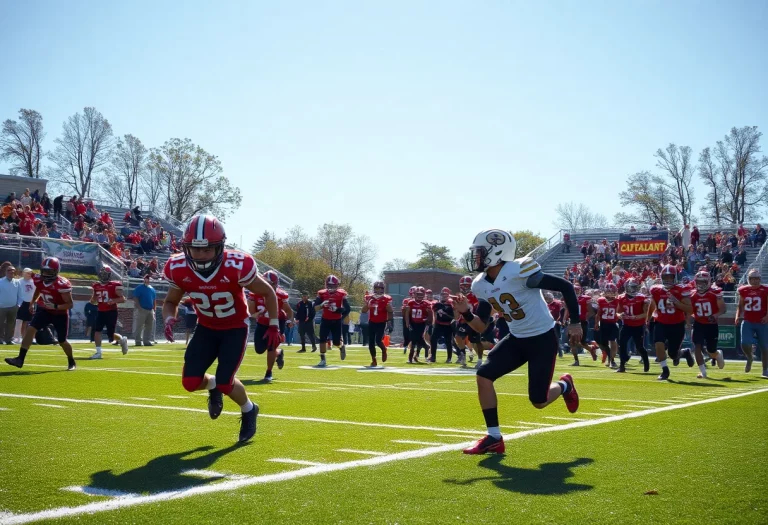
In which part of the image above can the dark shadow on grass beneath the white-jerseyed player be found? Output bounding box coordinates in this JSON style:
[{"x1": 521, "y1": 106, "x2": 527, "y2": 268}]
[{"x1": 445, "y1": 455, "x2": 594, "y2": 496}]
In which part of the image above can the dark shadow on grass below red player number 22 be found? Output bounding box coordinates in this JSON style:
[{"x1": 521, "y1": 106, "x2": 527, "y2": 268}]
[{"x1": 84, "y1": 444, "x2": 241, "y2": 494}]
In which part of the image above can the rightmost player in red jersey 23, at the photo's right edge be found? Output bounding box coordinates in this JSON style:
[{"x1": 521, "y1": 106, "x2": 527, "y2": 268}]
[{"x1": 736, "y1": 268, "x2": 768, "y2": 379}]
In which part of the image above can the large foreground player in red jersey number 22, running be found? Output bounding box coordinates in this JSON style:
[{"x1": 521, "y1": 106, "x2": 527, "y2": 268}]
[{"x1": 163, "y1": 215, "x2": 280, "y2": 442}]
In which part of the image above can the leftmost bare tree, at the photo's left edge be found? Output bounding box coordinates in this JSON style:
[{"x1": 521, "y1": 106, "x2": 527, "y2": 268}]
[{"x1": 0, "y1": 109, "x2": 45, "y2": 178}]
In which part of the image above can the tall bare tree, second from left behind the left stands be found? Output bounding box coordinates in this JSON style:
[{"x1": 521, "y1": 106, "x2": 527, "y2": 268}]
[{"x1": 49, "y1": 107, "x2": 113, "y2": 197}]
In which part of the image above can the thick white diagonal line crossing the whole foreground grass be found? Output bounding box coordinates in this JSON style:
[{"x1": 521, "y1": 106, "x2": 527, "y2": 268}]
[{"x1": 0, "y1": 388, "x2": 768, "y2": 525}]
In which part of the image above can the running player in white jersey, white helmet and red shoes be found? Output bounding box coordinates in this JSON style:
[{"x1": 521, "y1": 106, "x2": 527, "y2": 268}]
[{"x1": 454, "y1": 229, "x2": 583, "y2": 454}]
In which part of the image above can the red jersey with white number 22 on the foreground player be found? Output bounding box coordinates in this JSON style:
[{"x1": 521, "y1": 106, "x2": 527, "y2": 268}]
[{"x1": 163, "y1": 250, "x2": 259, "y2": 330}]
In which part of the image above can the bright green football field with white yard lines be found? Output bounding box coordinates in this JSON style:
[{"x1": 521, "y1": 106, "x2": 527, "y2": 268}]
[{"x1": 0, "y1": 345, "x2": 768, "y2": 525}]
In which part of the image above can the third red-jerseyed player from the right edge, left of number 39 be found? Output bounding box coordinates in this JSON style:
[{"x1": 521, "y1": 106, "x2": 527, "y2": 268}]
[{"x1": 646, "y1": 264, "x2": 694, "y2": 381}]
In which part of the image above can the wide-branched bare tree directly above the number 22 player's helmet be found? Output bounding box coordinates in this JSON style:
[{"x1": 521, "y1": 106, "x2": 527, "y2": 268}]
[{"x1": 150, "y1": 139, "x2": 242, "y2": 222}]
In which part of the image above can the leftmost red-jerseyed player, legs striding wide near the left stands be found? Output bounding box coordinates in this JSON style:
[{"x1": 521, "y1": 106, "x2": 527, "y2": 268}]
[{"x1": 5, "y1": 257, "x2": 77, "y2": 370}]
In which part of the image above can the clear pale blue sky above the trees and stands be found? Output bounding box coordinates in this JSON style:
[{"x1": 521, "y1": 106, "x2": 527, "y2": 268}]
[{"x1": 0, "y1": 0, "x2": 768, "y2": 266}]
